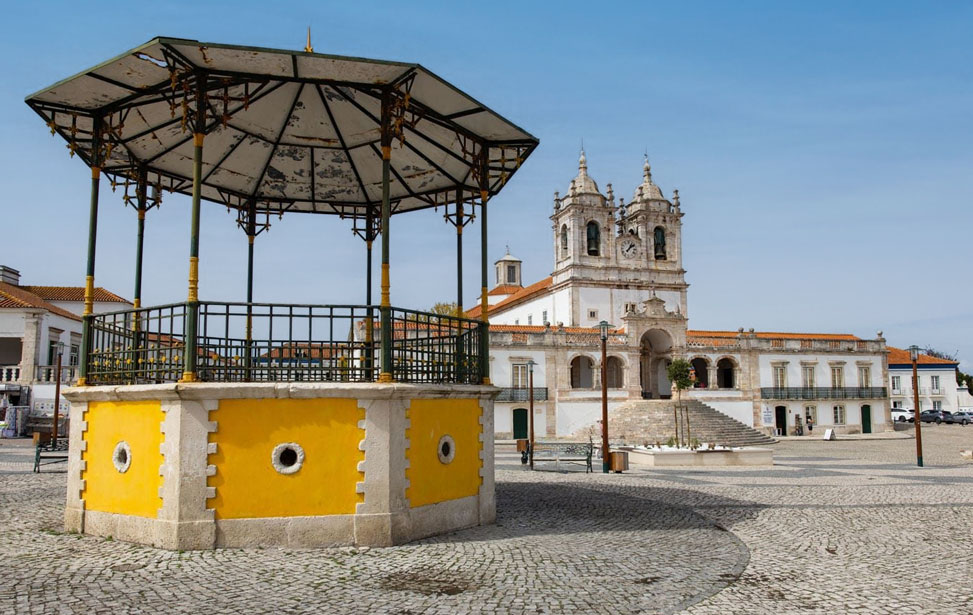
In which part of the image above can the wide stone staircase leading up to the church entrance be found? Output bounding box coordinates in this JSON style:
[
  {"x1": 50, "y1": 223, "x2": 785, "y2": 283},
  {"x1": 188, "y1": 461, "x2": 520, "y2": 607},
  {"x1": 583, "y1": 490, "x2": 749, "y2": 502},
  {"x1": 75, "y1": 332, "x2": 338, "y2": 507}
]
[{"x1": 574, "y1": 399, "x2": 776, "y2": 446}]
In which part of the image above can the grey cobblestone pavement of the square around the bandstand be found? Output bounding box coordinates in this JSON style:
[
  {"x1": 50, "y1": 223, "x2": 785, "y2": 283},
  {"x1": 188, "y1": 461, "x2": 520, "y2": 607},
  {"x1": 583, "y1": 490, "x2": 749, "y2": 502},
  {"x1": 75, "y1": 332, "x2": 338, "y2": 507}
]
[{"x1": 0, "y1": 425, "x2": 973, "y2": 615}]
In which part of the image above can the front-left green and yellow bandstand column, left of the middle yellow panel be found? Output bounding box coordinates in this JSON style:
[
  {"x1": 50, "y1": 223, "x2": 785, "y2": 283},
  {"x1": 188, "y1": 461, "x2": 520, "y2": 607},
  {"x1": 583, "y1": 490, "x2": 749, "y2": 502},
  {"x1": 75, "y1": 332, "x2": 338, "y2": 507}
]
[{"x1": 180, "y1": 75, "x2": 206, "y2": 382}]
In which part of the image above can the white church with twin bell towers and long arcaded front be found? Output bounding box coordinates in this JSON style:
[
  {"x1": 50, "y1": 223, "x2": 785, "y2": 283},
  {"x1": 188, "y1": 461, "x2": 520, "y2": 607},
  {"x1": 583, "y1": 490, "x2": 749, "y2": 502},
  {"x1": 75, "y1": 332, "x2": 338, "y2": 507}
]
[{"x1": 467, "y1": 151, "x2": 891, "y2": 440}]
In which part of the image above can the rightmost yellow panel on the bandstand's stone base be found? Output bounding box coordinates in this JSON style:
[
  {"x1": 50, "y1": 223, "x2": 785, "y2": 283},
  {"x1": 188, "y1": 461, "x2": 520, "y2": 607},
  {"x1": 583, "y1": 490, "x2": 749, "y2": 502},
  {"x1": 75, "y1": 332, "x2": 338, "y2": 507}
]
[{"x1": 405, "y1": 399, "x2": 482, "y2": 508}]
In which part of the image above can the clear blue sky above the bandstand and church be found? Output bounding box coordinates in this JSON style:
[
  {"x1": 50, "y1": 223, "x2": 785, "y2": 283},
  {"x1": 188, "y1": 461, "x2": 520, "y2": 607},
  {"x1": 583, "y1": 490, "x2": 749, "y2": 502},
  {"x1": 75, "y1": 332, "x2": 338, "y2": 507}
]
[{"x1": 0, "y1": 1, "x2": 973, "y2": 371}]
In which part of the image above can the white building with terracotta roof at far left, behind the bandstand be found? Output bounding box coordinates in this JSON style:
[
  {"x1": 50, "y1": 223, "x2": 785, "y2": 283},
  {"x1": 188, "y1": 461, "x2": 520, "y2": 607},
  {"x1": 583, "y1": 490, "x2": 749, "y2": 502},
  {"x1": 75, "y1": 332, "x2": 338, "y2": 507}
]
[{"x1": 0, "y1": 266, "x2": 132, "y2": 426}]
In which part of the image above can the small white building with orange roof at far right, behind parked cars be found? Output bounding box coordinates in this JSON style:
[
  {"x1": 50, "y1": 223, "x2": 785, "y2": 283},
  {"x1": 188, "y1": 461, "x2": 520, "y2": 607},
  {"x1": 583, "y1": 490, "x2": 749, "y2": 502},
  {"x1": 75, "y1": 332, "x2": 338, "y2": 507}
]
[{"x1": 888, "y1": 346, "x2": 970, "y2": 412}]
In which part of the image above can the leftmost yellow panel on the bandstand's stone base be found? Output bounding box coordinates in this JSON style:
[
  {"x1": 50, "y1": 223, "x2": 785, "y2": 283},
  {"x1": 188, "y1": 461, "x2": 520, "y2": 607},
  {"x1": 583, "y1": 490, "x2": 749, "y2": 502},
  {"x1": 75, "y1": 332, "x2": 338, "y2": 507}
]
[{"x1": 81, "y1": 401, "x2": 165, "y2": 518}]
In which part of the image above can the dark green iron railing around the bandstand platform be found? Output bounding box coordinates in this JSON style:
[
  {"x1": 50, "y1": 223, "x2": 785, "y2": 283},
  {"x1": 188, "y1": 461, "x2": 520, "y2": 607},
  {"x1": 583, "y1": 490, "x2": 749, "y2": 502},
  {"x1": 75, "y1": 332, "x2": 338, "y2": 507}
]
[{"x1": 87, "y1": 301, "x2": 483, "y2": 384}]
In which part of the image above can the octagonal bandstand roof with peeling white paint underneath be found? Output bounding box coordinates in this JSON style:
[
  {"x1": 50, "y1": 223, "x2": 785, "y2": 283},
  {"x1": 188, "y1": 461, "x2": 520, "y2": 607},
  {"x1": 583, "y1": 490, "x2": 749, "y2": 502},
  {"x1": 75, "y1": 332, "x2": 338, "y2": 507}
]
[{"x1": 27, "y1": 38, "x2": 538, "y2": 218}]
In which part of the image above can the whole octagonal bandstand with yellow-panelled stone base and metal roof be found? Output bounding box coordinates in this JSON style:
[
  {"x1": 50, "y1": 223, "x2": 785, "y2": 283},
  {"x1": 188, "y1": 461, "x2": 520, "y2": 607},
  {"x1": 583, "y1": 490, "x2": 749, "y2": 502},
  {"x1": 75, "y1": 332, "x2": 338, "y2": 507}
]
[{"x1": 27, "y1": 38, "x2": 537, "y2": 549}]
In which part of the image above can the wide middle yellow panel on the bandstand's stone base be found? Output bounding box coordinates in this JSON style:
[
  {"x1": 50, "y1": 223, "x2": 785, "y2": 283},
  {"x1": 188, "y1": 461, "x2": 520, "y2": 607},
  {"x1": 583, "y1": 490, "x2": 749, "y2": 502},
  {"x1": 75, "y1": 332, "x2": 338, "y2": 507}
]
[{"x1": 207, "y1": 398, "x2": 365, "y2": 519}]
